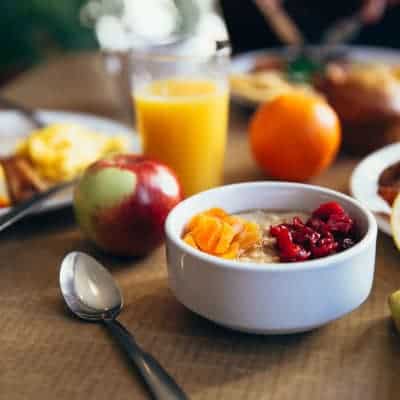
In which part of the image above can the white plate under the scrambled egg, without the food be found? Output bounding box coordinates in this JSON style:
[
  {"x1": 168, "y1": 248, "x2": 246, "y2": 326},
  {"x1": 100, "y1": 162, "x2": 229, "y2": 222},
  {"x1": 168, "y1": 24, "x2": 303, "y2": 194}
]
[{"x1": 0, "y1": 110, "x2": 140, "y2": 215}]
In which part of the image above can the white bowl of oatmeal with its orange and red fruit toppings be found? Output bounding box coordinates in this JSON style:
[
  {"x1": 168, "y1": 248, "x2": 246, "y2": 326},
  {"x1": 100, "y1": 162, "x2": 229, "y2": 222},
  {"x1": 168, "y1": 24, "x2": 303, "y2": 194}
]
[{"x1": 166, "y1": 182, "x2": 377, "y2": 334}]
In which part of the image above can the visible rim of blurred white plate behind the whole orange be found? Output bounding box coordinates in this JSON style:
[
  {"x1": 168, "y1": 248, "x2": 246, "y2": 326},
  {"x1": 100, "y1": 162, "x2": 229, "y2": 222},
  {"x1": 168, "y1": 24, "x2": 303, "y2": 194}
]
[{"x1": 230, "y1": 46, "x2": 400, "y2": 107}]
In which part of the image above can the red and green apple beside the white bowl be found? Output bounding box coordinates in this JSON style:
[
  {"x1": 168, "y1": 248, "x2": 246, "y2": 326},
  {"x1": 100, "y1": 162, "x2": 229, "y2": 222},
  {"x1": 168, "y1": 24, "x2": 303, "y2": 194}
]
[{"x1": 74, "y1": 154, "x2": 182, "y2": 256}]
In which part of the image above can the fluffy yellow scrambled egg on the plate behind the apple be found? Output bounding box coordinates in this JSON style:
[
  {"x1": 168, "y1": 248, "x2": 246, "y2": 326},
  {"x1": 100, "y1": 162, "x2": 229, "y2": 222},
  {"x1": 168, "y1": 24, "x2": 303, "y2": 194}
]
[{"x1": 16, "y1": 124, "x2": 128, "y2": 182}]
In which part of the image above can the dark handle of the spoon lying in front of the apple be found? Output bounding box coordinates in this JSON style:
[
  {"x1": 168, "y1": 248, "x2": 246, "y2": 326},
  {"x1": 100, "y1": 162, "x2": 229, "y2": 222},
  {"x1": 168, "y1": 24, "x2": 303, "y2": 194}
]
[{"x1": 104, "y1": 319, "x2": 189, "y2": 400}]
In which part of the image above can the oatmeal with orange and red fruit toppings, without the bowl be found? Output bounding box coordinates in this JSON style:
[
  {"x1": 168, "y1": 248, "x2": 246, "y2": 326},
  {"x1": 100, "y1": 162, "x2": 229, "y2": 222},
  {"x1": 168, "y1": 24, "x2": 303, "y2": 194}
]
[{"x1": 182, "y1": 202, "x2": 359, "y2": 264}]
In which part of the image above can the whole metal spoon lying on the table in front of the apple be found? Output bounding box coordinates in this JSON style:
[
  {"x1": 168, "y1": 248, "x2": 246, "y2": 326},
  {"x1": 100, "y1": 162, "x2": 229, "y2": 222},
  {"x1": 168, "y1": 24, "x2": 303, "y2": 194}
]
[{"x1": 60, "y1": 252, "x2": 188, "y2": 400}]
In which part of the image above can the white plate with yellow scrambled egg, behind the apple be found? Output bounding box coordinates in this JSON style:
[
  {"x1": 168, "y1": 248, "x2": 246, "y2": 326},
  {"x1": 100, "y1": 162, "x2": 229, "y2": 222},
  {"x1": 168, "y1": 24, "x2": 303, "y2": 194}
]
[{"x1": 0, "y1": 110, "x2": 141, "y2": 214}]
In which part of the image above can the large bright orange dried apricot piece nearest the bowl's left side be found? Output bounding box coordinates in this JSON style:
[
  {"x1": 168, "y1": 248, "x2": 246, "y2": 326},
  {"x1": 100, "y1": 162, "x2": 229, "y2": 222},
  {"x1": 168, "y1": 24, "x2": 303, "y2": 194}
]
[{"x1": 191, "y1": 215, "x2": 222, "y2": 253}]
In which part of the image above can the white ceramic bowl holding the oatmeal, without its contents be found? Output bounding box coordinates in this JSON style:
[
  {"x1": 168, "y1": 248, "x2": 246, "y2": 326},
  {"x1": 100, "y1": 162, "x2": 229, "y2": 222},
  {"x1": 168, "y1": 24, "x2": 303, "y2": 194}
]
[{"x1": 166, "y1": 182, "x2": 377, "y2": 334}]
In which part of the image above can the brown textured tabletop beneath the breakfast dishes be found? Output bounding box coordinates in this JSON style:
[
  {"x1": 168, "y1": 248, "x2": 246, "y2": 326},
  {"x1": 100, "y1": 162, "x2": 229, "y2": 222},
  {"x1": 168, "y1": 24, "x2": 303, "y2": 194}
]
[{"x1": 0, "y1": 50, "x2": 400, "y2": 400}]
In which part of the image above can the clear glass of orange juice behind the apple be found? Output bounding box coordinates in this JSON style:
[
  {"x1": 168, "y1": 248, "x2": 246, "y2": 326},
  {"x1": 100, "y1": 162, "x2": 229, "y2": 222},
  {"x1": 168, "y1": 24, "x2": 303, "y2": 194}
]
[{"x1": 131, "y1": 45, "x2": 229, "y2": 196}]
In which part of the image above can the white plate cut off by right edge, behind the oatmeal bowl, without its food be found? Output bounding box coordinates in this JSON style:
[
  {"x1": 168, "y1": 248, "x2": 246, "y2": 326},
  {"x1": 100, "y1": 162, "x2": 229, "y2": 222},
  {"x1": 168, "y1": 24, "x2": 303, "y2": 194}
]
[{"x1": 350, "y1": 143, "x2": 400, "y2": 235}]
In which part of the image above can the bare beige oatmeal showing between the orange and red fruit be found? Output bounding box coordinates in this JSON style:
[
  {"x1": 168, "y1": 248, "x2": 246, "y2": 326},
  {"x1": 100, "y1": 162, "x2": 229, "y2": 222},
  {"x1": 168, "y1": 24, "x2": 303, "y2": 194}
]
[{"x1": 235, "y1": 210, "x2": 310, "y2": 263}]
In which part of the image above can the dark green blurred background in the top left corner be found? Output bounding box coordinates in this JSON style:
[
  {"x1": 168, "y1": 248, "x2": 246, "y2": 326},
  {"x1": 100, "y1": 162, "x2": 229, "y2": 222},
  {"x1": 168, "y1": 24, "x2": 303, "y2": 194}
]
[{"x1": 0, "y1": 0, "x2": 97, "y2": 84}]
